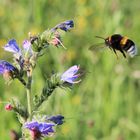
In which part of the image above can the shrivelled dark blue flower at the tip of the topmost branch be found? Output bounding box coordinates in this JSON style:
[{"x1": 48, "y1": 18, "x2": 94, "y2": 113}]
[{"x1": 52, "y1": 20, "x2": 74, "y2": 32}]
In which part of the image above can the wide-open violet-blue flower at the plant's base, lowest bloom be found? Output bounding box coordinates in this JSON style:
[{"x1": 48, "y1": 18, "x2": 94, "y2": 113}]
[{"x1": 24, "y1": 121, "x2": 55, "y2": 138}]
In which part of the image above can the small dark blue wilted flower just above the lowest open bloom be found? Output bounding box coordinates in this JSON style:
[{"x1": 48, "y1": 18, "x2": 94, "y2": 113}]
[{"x1": 47, "y1": 115, "x2": 64, "y2": 125}]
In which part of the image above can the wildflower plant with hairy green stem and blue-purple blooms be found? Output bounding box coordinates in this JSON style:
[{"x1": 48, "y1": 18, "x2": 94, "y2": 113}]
[{"x1": 0, "y1": 20, "x2": 80, "y2": 140}]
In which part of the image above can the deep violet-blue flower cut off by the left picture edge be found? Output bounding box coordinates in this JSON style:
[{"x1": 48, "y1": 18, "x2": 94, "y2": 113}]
[{"x1": 0, "y1": 60, "x2": 16, "y2": 74}]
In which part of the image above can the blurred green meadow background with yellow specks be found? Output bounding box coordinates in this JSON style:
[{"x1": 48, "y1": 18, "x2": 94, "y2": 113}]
[{"x1": 0, "y1": 0, "x2": 140, "y2": 140}]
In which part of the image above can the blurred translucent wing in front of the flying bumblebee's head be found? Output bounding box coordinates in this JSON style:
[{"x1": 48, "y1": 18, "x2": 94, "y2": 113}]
[{"x1": 88, "y1": 43, "x2": 106, "y2": 52}]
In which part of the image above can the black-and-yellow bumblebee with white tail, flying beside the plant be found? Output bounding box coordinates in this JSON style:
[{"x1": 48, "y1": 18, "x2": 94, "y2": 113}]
[{"x1": 89, "y1": 34, "x2": 137, "y2": 58}]
